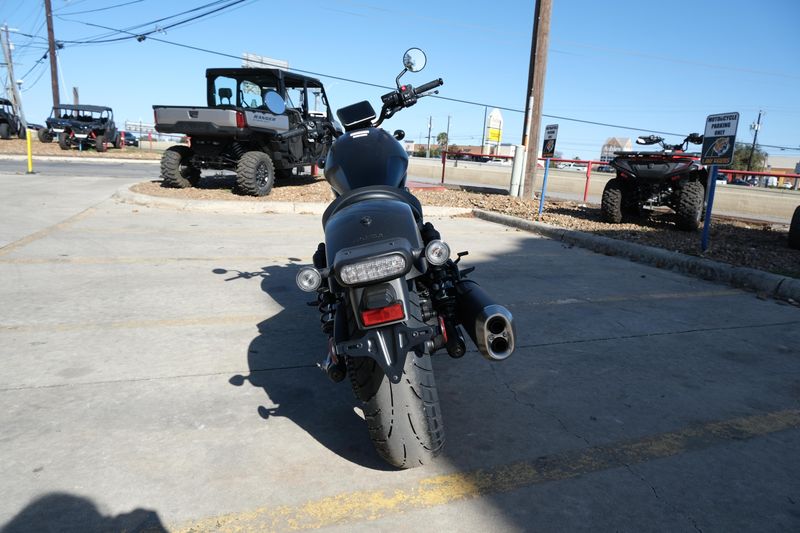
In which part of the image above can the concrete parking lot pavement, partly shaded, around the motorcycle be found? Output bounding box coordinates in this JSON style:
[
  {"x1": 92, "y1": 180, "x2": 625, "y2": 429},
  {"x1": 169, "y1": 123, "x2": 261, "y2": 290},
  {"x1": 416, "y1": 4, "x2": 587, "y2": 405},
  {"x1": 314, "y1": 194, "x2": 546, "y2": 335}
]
[{"x1": 0, "y1": 167, "x2": 800, "y2": 532}]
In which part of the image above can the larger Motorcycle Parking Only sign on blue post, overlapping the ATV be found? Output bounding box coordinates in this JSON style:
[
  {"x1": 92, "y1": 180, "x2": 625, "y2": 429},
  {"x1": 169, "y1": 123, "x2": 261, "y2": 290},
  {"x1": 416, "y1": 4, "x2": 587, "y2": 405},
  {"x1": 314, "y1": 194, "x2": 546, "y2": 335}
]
[{"x1": 700, "y1": 113, "x2": 739, "y2": 252}]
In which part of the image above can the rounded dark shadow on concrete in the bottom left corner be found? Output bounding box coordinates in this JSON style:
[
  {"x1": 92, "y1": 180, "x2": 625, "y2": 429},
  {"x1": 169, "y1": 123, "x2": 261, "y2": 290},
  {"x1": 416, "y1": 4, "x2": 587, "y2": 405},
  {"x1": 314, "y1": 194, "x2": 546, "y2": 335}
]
[{"x1": 0, "y1": 492, "x2": 167, "y2": 533}]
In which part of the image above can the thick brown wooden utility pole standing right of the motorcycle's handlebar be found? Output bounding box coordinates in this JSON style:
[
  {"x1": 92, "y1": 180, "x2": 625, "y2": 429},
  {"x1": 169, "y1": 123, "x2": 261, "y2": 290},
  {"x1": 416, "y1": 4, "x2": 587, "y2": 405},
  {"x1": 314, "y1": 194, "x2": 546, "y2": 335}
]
[{"x1": 520, "y1": 0, "x2": 553, "y2": 198}]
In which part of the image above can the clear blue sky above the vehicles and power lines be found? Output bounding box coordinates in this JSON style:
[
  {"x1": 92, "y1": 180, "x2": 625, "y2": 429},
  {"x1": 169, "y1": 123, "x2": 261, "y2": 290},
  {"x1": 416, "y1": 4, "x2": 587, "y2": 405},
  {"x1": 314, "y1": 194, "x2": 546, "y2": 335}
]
[{"x1": 0, "y1": 0, "x2": 800, "y2": 159}]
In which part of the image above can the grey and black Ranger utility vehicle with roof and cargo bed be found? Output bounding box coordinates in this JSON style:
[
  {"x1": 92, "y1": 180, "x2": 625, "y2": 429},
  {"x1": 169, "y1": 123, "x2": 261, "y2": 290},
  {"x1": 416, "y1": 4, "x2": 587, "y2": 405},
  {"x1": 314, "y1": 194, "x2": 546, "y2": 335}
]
[{"x1": 153, "y1": 68, "x2": 335, "y2": 196}]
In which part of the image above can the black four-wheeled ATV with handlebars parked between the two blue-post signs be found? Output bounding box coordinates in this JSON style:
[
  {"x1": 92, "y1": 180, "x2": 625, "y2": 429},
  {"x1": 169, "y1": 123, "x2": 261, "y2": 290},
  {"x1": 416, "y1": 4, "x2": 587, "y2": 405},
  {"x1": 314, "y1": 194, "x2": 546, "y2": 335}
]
[{"x1": 601, "y1": 133, "x2": 708, "y2": 231}]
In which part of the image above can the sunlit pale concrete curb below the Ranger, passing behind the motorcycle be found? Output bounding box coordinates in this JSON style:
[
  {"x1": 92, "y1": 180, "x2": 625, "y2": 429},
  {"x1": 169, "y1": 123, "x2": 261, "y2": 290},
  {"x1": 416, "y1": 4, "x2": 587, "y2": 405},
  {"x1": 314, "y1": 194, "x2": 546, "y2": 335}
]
[{"x1": 112, "y1": 183, "x2": 472, "y2": 217}]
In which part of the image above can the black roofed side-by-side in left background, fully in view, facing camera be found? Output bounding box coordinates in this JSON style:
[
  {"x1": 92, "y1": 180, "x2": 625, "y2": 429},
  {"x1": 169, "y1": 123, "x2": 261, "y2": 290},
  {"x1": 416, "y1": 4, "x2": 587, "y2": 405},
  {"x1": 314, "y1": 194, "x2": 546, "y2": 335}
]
[{"x1": 38, "y1": 104, "x2": 121, "y2": 152}]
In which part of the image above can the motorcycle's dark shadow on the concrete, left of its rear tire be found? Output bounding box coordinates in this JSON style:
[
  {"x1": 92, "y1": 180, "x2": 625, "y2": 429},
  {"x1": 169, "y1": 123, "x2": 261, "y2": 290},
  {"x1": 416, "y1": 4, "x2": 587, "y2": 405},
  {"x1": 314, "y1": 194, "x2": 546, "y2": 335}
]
[{"x1": 219, "y1": 264, "x2": 391, "y2": 470}]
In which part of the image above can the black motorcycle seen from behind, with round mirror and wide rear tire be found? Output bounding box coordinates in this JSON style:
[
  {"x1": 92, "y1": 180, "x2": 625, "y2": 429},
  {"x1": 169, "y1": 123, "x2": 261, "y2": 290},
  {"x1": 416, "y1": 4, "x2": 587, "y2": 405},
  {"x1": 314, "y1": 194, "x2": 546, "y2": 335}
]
[{"x1": 284, "y1": 48, "x2": 515, "y2": 468}]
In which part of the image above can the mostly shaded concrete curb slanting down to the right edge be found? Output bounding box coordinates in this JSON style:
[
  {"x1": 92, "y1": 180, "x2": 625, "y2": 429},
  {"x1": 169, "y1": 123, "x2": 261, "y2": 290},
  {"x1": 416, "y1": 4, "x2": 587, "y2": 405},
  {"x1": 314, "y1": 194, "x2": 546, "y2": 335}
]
[{"x1": 473, "y1": 209, "x2": 800, "y2": 302}]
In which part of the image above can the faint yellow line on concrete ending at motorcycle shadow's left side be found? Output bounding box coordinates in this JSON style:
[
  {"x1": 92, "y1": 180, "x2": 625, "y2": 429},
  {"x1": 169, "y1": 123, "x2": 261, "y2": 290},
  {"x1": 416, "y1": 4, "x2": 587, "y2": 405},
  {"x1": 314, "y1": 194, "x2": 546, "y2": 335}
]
[{"x1": 0, "y1": 311, "x2": 268, "y2": 333}]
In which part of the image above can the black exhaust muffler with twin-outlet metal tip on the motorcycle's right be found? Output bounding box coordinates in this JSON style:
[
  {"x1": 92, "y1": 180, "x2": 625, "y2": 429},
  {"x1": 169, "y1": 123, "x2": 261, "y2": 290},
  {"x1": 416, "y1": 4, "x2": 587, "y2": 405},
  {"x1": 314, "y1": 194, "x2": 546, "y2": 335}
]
[{"x1": 456, "y1": 280, "x2": 516, "y2": 361}]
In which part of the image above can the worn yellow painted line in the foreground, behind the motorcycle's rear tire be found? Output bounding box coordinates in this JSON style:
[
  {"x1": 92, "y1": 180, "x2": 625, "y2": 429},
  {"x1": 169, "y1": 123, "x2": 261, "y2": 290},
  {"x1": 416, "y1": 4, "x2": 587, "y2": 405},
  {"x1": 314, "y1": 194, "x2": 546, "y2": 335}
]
[{"x1": 169, "y1": 409, "x2": 800, "y2": 533}]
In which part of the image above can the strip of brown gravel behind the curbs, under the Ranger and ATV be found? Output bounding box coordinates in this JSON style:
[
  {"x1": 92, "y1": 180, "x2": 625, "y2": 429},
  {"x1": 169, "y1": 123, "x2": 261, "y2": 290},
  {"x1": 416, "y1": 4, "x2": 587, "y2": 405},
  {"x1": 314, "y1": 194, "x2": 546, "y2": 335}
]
[{"x1": 132, "y1": 174, "x2": 800, "y2": 278}]
